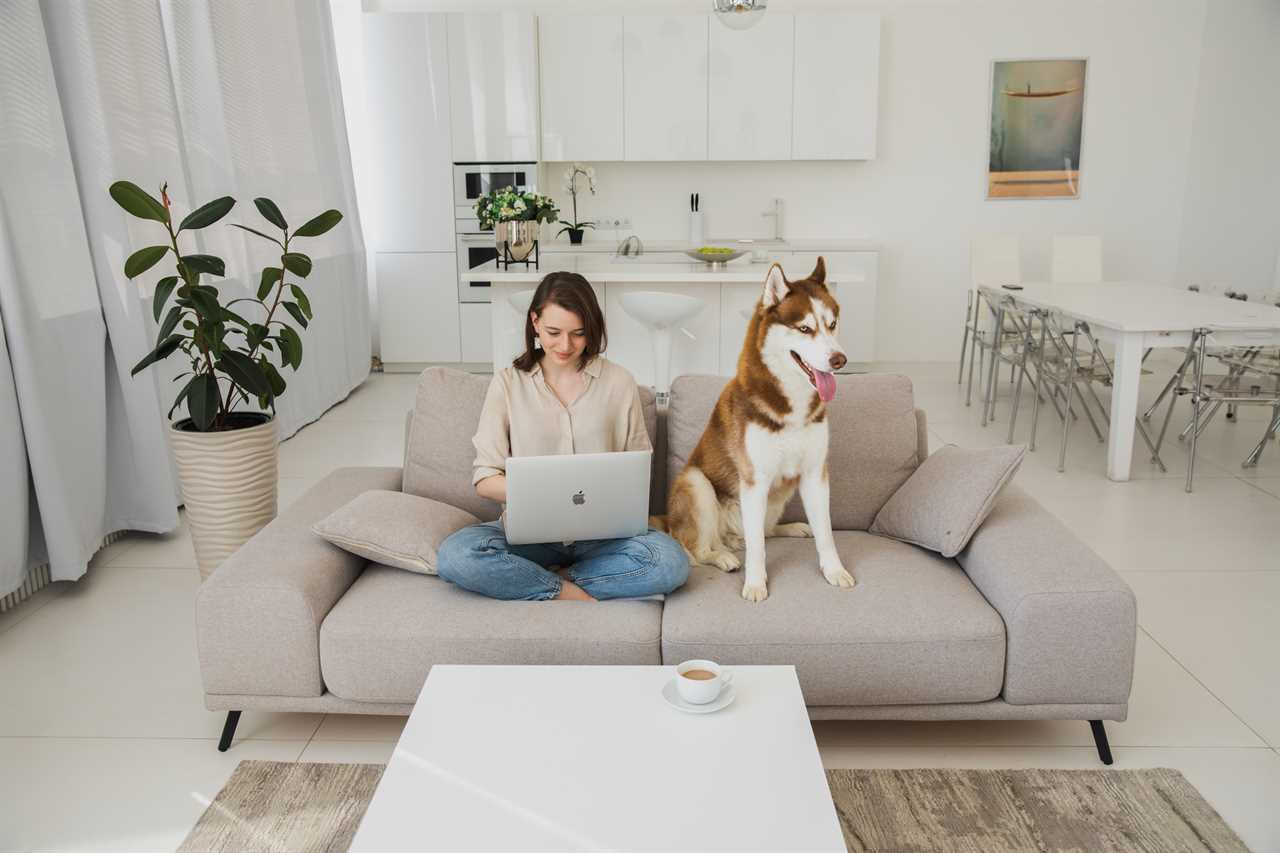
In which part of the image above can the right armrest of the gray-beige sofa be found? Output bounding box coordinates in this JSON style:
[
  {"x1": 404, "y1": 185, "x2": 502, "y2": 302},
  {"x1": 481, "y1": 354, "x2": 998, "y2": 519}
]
[{"x1": 956, "y1": 485, "x2": 1138, "y2": 704}]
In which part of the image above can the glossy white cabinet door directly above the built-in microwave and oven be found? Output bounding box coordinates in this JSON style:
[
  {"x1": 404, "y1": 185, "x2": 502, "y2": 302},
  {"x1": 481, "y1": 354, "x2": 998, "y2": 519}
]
[{"x1": 448, "y1": 12, "x2": 538, "y2": 161}]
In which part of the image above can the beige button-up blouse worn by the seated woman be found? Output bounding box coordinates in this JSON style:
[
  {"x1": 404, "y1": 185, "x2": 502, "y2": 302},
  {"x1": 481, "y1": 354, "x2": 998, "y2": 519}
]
[{"x1": 471, "y1": 357, "x2": 653, "y2": 484}]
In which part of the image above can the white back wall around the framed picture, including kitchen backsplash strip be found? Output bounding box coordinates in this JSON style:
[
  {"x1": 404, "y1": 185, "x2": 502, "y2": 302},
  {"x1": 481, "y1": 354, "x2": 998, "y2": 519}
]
[{"x1": 544, "y1": 0, "x2": 1208, "y2": 360}]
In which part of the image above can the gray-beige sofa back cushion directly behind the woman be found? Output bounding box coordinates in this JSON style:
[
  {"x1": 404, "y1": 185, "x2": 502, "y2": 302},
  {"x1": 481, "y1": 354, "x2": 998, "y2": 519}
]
[{"x1": 404, "y1": 368, "x2": 666, "y2": 521}]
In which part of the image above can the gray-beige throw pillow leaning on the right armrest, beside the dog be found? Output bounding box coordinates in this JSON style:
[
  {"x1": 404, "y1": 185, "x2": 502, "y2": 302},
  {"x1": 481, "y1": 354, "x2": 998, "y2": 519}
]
[{"x1": 870, "y1": 444, "x2": 1027, "y2": 557}]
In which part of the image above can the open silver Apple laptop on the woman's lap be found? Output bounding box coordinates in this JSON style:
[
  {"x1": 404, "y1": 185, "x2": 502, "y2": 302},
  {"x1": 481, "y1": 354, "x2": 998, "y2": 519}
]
[{"x1": 503, "y1": 451, "x2": 653, "y2": 544}]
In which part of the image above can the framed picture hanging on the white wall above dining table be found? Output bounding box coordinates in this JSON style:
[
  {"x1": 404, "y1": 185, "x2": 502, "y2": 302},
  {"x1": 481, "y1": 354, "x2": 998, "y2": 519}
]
[{"x1": 987, "y1": 59, "x2": 1088, "y2": 199}]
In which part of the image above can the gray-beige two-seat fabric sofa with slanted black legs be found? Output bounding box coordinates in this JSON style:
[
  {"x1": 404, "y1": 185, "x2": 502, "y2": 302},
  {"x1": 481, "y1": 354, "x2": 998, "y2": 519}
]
[{"x1": 196, "y1": 369, "x2": 1137, "y2": 763}]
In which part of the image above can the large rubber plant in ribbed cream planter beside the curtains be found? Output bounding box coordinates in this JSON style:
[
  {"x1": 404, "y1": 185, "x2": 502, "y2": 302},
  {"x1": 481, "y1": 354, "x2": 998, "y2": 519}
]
[{"x1": 110, "y1": 181, "x2": 342, "y2": 579}]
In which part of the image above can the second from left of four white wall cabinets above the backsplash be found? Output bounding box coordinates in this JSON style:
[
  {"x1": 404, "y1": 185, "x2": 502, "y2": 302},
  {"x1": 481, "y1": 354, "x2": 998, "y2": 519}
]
[{"x1": 622, "y1": 15, "x2": 709, "y2": 160}]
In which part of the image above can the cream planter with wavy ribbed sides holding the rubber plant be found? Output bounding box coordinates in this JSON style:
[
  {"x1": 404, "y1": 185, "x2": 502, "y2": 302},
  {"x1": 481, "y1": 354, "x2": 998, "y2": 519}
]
[{"x1": 169, "y1": 419, "x2": 279, "y2": 580}]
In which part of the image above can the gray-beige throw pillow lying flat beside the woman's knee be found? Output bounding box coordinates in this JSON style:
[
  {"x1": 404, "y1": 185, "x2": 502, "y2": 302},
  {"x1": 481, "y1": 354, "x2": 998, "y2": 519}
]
[{"x1": 311, "y1": 489, "x2": 480, "y2": 575}]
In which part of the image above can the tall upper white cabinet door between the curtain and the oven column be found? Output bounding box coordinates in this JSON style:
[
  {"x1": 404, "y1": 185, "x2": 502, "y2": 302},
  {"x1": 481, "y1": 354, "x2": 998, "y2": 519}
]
[{"x1": 361, "y1": 13, "x2": 453, "y2": 252}]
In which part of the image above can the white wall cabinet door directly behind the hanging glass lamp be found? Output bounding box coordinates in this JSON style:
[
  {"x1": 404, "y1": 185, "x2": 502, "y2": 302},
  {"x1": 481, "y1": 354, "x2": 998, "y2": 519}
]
[{"x1": 708, "y1": 12, "x2": 795, "y2": 160}]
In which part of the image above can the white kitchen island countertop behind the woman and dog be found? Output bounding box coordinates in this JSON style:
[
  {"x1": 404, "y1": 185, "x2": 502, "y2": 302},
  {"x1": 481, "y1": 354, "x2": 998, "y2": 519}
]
[{"x1": 462, "y1": 255, "x2": 867, "y2": 286}]
